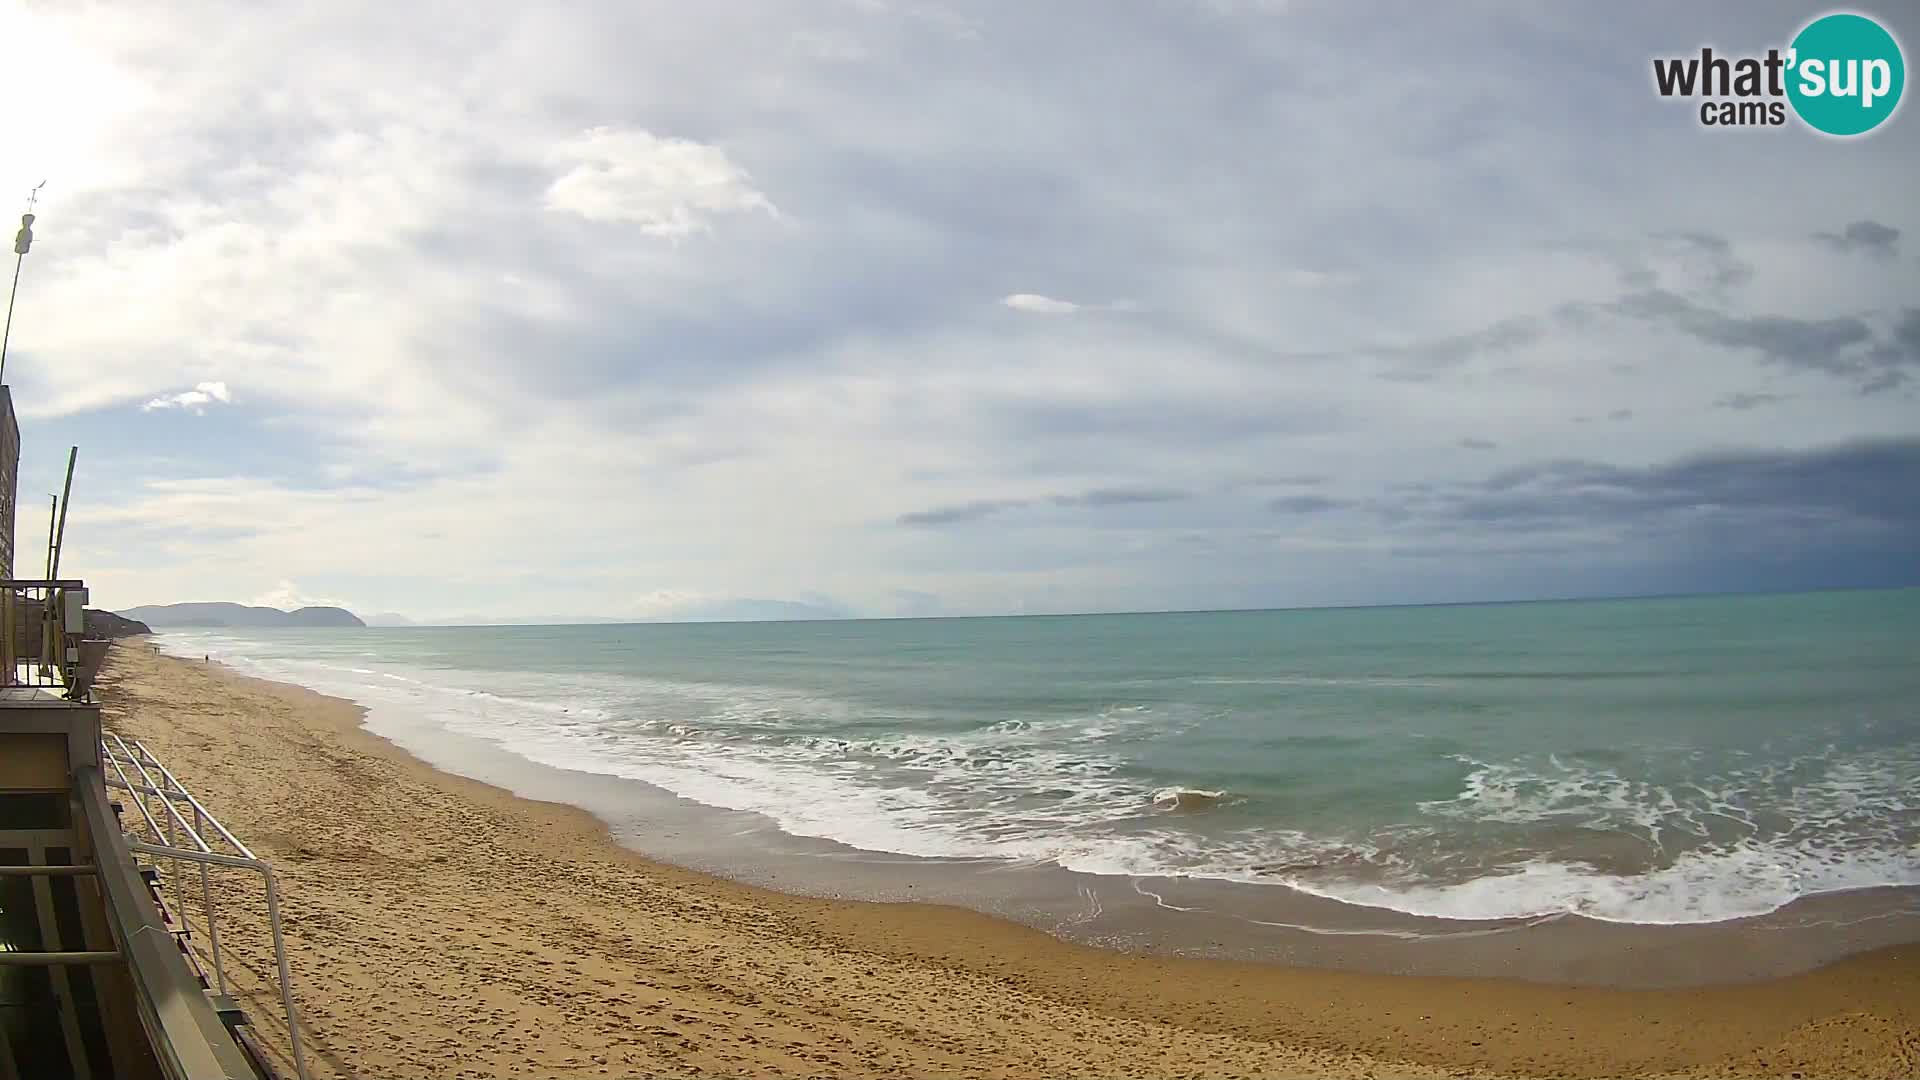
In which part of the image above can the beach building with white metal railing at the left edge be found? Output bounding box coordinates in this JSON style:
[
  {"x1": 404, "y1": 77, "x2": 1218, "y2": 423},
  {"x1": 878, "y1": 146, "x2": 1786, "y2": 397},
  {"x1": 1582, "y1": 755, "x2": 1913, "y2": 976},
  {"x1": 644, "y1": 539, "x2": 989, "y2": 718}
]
[{"x1": 0, "y1": 386, "x2": 305, "y2": 1080}]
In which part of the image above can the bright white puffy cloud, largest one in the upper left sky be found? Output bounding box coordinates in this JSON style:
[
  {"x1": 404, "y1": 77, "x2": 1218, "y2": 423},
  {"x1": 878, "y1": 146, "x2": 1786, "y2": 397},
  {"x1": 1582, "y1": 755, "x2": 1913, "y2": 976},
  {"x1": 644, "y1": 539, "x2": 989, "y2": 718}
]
[{"x1": 547, "y1": 127, "x2": 776, "y2": 236}]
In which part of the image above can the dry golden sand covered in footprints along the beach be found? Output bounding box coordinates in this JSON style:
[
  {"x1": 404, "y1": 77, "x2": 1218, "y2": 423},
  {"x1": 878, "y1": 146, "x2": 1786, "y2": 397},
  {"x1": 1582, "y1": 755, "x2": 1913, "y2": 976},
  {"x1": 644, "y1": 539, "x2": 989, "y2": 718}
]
[{"x1": 100, "y1": 646, "x2": 1920, "y2": 1080}]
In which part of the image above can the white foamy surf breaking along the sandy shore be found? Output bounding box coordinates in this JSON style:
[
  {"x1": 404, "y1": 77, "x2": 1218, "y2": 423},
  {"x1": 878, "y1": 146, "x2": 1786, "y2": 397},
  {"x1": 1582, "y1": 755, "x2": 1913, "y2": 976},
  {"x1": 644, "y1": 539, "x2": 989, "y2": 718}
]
[{"x1": 165, "y1": 634, "x2": 1920, "y2": 922}]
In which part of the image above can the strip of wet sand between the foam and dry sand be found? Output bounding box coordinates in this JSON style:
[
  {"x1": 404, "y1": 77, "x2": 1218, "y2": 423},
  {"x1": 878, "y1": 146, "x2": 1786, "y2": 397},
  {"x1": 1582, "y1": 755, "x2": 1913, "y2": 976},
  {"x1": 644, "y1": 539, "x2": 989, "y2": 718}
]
[{"x1": 349, "y1": 645, "x2": 1920, "y2": 988}]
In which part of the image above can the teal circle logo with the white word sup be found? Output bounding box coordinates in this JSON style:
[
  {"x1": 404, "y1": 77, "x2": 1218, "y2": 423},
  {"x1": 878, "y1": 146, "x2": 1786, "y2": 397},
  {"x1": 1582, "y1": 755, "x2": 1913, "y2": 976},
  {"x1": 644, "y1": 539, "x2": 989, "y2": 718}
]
[{"x1": 1788, "y1": 12, "x2": 1907, "y2": 136}]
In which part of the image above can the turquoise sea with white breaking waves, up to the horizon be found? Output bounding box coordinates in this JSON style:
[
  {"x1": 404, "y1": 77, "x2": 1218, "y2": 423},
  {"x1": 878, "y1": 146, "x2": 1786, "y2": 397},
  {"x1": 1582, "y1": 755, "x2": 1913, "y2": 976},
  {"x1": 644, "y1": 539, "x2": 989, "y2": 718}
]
[{"x1": 163, "y1": 590, "x2": 1920, "y2": 922}]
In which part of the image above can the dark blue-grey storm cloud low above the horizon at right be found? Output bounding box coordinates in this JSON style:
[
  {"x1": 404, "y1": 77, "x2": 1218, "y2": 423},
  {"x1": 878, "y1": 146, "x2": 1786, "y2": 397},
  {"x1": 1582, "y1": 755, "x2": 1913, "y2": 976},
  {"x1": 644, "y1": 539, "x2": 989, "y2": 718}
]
[{"x1": 1407, "y1": 438, "x2": 1920, "y2": 534}]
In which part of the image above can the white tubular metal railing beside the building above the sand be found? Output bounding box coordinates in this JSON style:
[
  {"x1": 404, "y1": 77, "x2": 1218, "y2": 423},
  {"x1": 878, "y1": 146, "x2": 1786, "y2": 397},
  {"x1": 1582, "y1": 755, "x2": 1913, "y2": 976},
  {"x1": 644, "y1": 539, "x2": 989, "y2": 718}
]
[{"x1": 100, "y1": 732, "x2": 307, "y2": 1080}]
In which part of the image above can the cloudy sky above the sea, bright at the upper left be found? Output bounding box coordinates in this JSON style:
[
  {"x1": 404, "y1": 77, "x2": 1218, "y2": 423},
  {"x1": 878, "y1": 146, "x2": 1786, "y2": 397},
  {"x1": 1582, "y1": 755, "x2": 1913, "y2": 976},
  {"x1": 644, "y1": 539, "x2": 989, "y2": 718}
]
[{"x1": 0, "y1": 0, "x2": 1920, "y2": 621}]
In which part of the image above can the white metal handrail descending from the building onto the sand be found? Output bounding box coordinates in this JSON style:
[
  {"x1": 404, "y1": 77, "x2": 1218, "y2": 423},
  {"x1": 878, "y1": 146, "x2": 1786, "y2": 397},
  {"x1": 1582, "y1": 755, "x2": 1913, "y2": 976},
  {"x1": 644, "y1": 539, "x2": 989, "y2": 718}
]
[{"x1": 100, "y1": 732, "x2": 307, "y2": 1080}]
